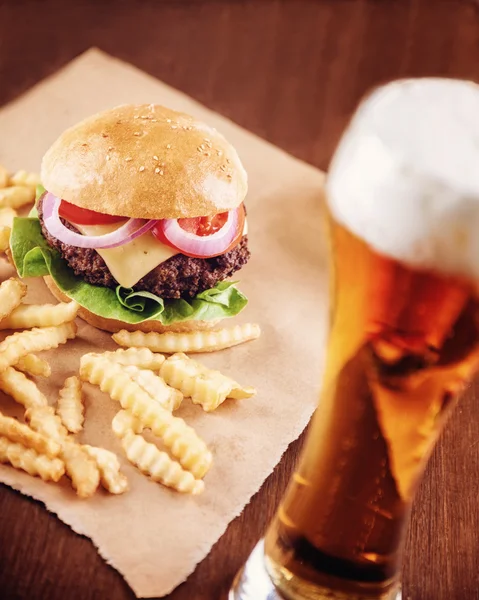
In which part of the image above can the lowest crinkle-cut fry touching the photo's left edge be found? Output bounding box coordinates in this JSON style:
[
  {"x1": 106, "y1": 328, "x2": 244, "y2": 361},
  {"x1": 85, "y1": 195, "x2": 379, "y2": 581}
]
[{"x1": 0, "y1": 437, "x2": 65, "y2": 482}]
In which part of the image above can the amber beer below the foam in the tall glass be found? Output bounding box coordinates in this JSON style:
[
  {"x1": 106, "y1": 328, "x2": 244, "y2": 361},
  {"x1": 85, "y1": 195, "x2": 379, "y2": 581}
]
[{"x1": 265, "y1": 213, "x2": 479, "y2": 600}]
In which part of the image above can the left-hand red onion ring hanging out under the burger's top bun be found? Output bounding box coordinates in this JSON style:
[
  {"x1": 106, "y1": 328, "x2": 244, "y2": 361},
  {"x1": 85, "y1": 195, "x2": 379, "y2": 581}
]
[{"x1": 43, "y1": 192, "x2": 157, "y2": 248}]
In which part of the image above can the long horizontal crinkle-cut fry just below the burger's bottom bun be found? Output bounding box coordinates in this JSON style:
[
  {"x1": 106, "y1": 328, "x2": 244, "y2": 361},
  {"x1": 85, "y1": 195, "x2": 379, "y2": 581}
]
[{"x1": 112, "y1": 323, "x2": 261, "y2": 354}]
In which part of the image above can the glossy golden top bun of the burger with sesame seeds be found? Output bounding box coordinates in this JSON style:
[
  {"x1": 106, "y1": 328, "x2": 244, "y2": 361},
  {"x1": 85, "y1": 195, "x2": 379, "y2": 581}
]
[{"x1": 41, "y1": 104, "x2": 247, "y2": 219}]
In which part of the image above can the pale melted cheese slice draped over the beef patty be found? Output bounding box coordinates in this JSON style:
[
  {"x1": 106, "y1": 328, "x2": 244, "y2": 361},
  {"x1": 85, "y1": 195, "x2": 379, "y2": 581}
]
[{"x1": 75, "y1": 220, "x2": 248, "y2": 288}]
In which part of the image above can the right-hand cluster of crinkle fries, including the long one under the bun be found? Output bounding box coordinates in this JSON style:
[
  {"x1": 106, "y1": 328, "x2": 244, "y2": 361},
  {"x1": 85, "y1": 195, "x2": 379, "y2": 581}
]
[{"x1": 80, "y1": 324, "x2": 260, "y2": 494}]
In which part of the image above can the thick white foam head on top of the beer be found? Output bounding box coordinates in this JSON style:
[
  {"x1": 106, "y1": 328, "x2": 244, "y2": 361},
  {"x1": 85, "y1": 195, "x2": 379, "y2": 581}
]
[{"x1": 327, "y1": 78, "x2": 479, "y2": 278}]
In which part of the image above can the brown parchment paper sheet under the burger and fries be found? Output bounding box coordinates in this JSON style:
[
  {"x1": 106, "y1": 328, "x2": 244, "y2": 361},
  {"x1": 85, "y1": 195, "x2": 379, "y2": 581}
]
[{"x1": 0, "y1": 49, "x2": 327, "y2": 597}]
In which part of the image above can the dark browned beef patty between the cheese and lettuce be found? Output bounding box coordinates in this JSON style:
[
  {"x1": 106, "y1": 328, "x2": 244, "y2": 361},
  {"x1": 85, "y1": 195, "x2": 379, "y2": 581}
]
[{"x1": 38, "y1": 200, "x2": 250, "y2": 299}]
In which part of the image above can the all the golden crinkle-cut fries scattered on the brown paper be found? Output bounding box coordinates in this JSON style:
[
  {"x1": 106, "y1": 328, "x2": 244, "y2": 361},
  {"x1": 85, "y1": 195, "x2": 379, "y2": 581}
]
[{"x1": 0, "y1": 166, "x2": 260, "y2": 498}]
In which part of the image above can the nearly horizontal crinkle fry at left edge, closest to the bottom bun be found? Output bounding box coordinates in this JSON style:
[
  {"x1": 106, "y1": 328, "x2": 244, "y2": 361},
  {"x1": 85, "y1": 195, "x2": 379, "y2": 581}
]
[{"x1": 0, "y1": 301, "x2": 79, "y2": 329}]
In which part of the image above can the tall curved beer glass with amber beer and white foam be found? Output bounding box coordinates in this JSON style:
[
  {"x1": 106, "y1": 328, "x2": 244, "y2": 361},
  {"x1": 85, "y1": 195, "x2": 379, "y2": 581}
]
[{"x1": 230, "y1": 79, "x2": 479, "y2": 600}]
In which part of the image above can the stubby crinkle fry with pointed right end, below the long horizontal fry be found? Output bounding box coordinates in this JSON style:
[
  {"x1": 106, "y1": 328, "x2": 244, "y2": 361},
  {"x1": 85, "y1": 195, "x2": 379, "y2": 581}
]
[{"x1": 160, "y1": 353, "x2": 256, "y2": 412}]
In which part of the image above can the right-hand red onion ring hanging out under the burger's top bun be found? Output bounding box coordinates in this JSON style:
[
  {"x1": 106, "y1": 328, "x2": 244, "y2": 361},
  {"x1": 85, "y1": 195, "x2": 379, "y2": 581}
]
[{"x1": 159, "y1": 209, "x2": 238, "y2": 258}]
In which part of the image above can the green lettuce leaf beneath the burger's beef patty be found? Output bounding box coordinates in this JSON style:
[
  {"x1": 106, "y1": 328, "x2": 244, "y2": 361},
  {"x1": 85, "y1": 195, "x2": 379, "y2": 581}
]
[{"x1": 10, "y1": 218, "x2": 248, "y2": 325}]
